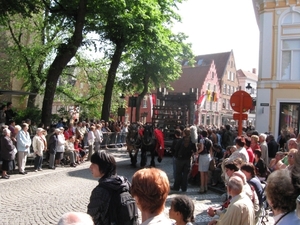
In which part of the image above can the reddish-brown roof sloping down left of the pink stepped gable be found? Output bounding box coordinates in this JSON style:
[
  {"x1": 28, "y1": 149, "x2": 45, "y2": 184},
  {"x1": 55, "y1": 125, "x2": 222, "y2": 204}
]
[{"x1": 169, "y1": 64, "x2": 211, "y2": 93}]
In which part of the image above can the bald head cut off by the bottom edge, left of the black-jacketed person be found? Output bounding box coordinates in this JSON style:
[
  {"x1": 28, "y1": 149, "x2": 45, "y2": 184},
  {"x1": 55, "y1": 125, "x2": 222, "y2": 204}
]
[{"x1": 57, "y1": 212, "x2": 94, "y2": 225}]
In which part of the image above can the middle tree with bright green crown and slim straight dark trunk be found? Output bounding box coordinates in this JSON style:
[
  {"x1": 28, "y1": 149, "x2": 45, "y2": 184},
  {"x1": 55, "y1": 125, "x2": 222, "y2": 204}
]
[{"x1": 92, "y1": 0, "x2": 190, "y2": 120}]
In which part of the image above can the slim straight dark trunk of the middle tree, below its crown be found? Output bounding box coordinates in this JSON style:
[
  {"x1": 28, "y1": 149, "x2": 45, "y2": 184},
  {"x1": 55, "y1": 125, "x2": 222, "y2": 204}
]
[{"x1": 101, "y1": 41, "x2": 125, "y2": 122}]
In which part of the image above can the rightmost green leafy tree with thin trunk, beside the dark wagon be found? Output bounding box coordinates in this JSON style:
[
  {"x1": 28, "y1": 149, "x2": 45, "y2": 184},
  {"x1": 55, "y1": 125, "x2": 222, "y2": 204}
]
[{"x1": 122, "y1": 31, "x2": 194, "y2": 121}]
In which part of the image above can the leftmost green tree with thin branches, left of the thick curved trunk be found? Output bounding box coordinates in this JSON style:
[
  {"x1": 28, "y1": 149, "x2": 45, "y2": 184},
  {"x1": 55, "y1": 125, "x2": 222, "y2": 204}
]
[{"x1": 0, "y1": 11, "x2": 53, "y2": 107}]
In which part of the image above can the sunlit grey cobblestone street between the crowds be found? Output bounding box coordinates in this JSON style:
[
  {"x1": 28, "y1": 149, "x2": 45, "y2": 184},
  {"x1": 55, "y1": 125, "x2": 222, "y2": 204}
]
[{"x1": 0, "y1": 149, "x2": 274, "y2": 225}]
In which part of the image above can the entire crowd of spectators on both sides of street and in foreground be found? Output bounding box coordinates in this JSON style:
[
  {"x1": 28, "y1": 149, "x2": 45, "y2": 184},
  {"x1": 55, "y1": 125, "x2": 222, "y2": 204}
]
[{"x1": 0, "y1": 101, "x2": 300, "y2": 225}]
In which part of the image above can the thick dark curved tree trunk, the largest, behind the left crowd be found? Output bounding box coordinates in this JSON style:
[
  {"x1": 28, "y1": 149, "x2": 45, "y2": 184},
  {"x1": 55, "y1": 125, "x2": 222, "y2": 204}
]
[{"x1": 42, "y1": 0, "x2": 87, "y2": 126}]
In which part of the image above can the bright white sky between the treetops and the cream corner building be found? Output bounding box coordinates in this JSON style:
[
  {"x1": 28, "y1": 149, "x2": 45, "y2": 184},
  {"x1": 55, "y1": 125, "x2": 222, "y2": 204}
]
[{"x1": 173, "y1": 0, "x2": 259, "y2": 71}]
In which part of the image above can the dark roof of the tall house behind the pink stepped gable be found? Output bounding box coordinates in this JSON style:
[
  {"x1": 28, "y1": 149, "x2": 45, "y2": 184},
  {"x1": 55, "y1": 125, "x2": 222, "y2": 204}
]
[{"x1": 195, "y1": 51, "x2": 231, "y2": 79}]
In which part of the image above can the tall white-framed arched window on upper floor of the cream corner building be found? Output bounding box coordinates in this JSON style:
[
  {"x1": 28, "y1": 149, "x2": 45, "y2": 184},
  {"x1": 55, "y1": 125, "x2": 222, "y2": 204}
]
[{"x1": 277, "y1": 7, "x2": 300, "y2": 80}]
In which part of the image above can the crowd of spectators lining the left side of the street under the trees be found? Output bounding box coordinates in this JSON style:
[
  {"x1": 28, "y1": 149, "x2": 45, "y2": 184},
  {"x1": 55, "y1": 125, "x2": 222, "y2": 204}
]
[{"x1": 0, "y1": 114, "x2": 128, "y2": 179}]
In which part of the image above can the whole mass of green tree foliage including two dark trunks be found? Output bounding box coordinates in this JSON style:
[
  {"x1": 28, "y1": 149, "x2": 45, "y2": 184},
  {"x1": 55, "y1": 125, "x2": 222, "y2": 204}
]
[{"x1": 0, "y1": 0, "x2": 190, "y2": 125}]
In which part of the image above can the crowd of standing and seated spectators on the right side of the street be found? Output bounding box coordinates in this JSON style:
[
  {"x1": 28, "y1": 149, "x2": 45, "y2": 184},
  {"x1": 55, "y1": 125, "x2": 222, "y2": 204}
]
[{"x1": 171, "y1": 125, "x2": 300, "y2": 225}]
